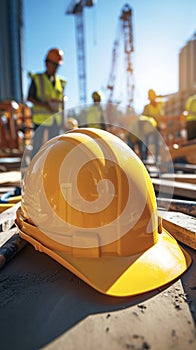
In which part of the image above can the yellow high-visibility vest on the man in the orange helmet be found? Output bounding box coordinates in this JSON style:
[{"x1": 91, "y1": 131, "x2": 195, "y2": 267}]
[{"x1": 30, "y1": 73, "x2": 66, "y2": 126}]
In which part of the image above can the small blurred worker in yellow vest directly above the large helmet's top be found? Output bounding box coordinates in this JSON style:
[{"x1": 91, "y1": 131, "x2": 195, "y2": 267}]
[{"x1": 86, "y1": 91, "x2": 106, "y2": 130}]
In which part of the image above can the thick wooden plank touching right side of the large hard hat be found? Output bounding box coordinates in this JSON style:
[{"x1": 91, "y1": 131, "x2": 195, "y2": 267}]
[{"x1": 159, "y1": 211, "x2": 196, "y2": 250}]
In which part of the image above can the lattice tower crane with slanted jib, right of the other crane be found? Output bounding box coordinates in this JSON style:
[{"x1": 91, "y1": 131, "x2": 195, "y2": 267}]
[{"x1": 107, "y1": 4, "x2": 134, "y2": 107}]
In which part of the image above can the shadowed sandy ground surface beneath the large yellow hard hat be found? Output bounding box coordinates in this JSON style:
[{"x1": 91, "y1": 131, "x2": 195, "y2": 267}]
[{"x1": 0, "y1": 241, "x2": 196, "y2": 350}]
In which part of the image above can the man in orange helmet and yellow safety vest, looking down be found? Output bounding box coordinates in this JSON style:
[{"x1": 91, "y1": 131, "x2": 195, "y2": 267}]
[{"x1": 27, "y1": 48, "x2": 66, "y2": 157}]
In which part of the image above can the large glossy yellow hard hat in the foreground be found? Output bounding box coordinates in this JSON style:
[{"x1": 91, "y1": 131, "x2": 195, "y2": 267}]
[{"x1": 16, "y1": 128, "x2": 191, "y2": 297}]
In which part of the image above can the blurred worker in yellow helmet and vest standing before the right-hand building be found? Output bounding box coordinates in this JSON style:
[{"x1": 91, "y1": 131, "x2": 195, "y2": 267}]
[{"x1": 140, "y1": 89, "x2": 164, "y2": 161}]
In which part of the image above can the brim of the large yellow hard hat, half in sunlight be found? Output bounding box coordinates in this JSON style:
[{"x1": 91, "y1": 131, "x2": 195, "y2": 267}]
[{"x1": 16, "y1": 221, "x2": 191, "y2": 297}]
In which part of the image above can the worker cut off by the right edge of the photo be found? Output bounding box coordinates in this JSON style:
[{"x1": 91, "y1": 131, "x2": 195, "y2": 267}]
[{"x1": 184, "y1": 94, "x2": 196, "y2": 140}]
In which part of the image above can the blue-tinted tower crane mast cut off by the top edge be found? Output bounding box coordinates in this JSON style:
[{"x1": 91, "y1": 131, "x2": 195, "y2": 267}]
[{"x1": 65, "y1": 0, "x2": 94, "y2": 104}]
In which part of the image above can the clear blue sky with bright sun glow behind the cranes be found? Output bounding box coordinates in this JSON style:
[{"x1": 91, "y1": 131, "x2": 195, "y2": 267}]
[{"x1": 23, "y1": 0, "x2": 196, "y2": 113}]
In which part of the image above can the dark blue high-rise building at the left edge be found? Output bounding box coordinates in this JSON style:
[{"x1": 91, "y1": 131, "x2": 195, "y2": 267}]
[{"x1": 0, "y1": 0, "x2": 23, "y2": 102}]
